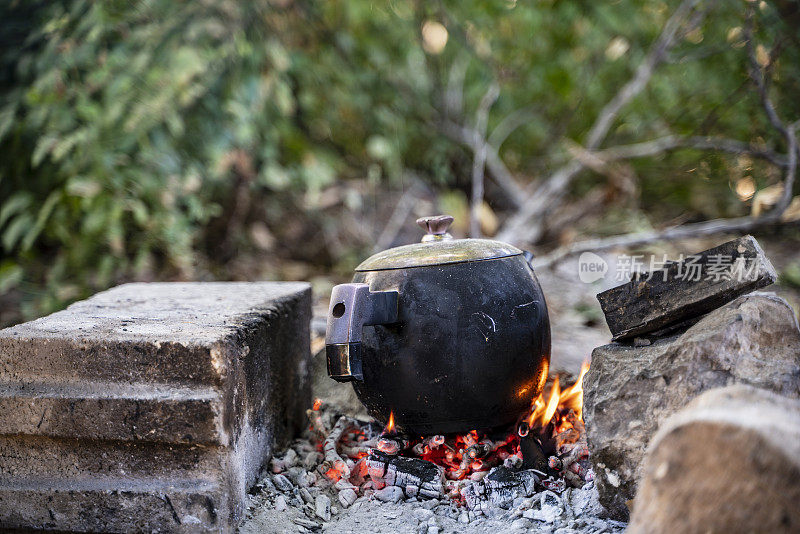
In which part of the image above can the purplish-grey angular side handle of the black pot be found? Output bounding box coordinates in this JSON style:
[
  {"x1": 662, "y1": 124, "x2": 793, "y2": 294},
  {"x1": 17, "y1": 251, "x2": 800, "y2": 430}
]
[{"x1": 325, "y1": 284, "x2": 398, "y2": 382}]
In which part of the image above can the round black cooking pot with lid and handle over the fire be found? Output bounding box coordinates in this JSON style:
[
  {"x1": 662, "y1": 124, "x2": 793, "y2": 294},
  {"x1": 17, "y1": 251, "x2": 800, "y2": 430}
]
[{"x1": 326, "y1": 216, "x2": 550, "y2": 435}]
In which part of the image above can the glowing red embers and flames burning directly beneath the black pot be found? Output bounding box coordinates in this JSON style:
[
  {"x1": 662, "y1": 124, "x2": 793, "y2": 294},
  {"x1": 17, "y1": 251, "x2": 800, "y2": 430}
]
[{"x1": 309, "y1": 364, "x2": 594, "y2": 508}]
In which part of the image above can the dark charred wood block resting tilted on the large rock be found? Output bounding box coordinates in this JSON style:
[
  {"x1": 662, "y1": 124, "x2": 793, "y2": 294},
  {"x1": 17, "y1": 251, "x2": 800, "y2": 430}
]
[{"x1": 597, "y1": 235, "x2": 777, "y2": 341}]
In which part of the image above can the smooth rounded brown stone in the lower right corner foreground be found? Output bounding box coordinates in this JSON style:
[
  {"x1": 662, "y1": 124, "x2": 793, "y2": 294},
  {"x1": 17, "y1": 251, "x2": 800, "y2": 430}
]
[{"x1": 628, "y1": 386, "x2": 800, "y2": 534}]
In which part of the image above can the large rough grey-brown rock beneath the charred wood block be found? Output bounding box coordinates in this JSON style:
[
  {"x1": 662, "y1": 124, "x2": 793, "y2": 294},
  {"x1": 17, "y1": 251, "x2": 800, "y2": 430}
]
[{"x1": 583, "y1": 293, "x2": 800, "y2": 519}]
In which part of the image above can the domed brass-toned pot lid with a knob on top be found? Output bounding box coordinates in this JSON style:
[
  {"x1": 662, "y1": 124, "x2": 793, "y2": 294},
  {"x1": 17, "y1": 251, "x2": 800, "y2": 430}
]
[{"x1": 356, "y1": 215, "x2": 522, "y2": 271}]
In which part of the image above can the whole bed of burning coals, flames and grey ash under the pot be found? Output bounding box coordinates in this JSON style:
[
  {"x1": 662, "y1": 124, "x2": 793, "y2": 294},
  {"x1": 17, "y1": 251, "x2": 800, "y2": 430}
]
[{"x1": 240, "y1": 381, "x2": 626, "y2": 534}]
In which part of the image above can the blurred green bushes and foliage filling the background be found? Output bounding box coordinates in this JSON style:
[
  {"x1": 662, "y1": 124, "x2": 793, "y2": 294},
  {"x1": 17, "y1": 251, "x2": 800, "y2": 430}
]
[{"x1": 0, "y1": 0, "x2": 800, "y2": 324}]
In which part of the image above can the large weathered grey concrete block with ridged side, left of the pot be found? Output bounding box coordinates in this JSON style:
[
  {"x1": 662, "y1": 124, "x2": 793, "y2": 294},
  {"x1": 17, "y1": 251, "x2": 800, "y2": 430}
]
[{"x1": 0, "y1": 283, "x2": 310, "y2": 532}]
